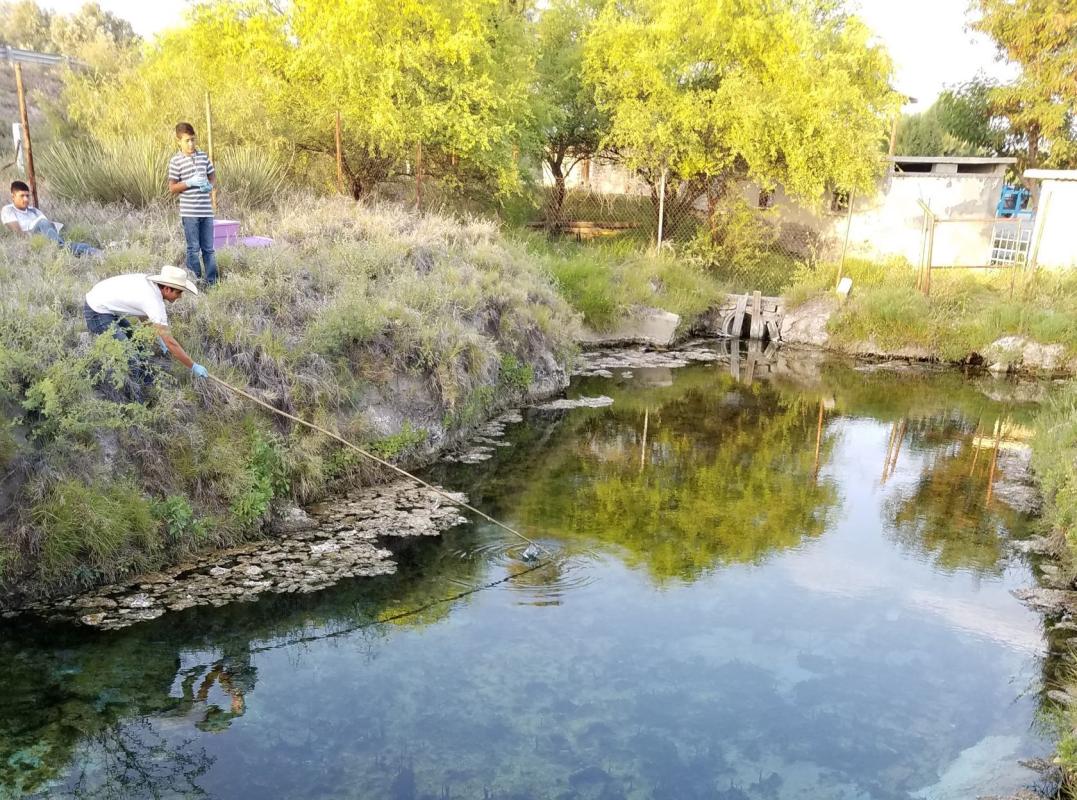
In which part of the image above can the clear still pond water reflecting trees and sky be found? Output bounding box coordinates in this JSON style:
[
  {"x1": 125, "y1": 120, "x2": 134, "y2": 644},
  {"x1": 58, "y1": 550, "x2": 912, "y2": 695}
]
[{"x1": 0, "y1": 363, "x2": 1051, "y2": 800}]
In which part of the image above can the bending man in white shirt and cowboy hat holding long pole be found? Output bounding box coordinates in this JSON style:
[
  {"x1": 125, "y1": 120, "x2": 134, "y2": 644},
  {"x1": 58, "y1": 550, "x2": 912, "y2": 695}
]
[{"x1": 82, "y1": 266, "x2": 208, "y2": 383}]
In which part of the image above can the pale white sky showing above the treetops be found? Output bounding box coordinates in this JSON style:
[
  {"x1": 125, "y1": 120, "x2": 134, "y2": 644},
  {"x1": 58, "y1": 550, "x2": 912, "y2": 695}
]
[{"x1": 41, "y1": 0, "x2": 1013, "y2": 111}]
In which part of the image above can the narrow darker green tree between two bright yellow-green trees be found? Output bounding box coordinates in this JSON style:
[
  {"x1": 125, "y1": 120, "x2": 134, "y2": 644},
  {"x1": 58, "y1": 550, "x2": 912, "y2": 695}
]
[{"x1": 535, "y1": 0, "x2": 610, "y2": 219}]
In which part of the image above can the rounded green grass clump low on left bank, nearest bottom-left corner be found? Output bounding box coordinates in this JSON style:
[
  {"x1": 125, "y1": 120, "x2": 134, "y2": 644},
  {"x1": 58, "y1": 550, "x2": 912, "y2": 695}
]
[{"x1": 31, "y1": 478, "x2": 159, "y2": 578}]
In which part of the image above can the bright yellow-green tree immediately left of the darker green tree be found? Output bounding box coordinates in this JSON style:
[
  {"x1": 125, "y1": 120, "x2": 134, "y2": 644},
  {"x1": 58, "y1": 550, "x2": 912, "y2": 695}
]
[{"x1": 279, "y1": 0, "x2": 532, "y2": 197}]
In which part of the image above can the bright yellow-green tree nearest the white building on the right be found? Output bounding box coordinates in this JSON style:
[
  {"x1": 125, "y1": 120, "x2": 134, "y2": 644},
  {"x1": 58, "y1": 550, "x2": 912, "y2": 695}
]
[{"x1": 587, "y1": 0, "x2": 897, "y2": 225}]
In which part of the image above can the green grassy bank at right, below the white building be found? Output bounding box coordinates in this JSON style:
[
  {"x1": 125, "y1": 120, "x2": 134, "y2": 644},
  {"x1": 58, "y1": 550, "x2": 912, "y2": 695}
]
[{"x1": 786, "y1": 259, "x2": 1077, "y2": 361}]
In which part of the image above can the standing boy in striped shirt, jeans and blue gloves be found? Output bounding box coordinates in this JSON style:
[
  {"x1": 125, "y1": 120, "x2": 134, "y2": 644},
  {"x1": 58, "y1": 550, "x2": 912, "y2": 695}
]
[{"x1": 168, "y1": 123, "x2": 216, "y2": 286}]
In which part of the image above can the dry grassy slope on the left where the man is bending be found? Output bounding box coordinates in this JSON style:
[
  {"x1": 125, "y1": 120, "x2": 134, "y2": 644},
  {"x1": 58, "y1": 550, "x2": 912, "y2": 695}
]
[{"x1": 0, "y1": 197, "x2": 577, "y2": 594}]
